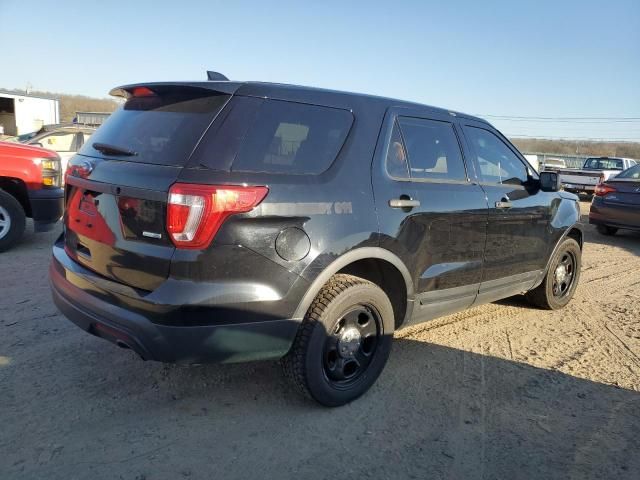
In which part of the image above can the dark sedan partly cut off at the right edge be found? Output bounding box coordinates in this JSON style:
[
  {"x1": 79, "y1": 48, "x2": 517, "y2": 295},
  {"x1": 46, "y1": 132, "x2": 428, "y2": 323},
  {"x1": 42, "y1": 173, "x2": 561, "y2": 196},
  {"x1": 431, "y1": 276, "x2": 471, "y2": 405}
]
[{"x1": 589, "y1": 165, "x2": 640, "y2": 235}]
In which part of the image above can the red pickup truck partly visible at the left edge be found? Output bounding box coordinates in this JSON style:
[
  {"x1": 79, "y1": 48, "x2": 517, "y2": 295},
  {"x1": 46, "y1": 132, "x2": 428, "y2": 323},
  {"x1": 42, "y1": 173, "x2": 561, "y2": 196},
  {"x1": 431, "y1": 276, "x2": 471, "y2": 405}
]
[{"x1": 0, "y1": 142, "x2": 64, "y2": 252}]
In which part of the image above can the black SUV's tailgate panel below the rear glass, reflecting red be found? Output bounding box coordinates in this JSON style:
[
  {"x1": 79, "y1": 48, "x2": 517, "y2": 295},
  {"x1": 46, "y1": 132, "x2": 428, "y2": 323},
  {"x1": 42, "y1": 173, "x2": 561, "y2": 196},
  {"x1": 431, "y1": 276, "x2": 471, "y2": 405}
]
[{"x1": 64, "y1": 164, "x2": 180, "y2": 290}]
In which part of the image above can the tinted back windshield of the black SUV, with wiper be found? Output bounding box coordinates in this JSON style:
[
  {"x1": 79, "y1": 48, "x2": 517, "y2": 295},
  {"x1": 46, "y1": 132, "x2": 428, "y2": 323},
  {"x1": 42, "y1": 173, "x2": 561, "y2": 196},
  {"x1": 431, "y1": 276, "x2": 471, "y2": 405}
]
[{"x1": 80, "y1": 89, "x2": 229, "y2": 165}]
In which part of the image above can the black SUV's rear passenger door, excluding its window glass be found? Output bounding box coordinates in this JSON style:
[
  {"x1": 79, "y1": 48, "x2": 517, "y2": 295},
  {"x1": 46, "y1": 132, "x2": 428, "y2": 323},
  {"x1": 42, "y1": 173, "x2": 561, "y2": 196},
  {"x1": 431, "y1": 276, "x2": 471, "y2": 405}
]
[{"x1": 372, "y1": 108, "x2": 487, "y2": 322}]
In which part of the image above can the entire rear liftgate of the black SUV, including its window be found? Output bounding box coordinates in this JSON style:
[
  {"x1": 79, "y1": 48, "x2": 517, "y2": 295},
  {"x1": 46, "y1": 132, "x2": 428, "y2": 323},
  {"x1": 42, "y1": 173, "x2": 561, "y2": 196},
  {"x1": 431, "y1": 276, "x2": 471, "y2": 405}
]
[{"x1": 64, "y1": 84, "x2": 230, "y2": 291}]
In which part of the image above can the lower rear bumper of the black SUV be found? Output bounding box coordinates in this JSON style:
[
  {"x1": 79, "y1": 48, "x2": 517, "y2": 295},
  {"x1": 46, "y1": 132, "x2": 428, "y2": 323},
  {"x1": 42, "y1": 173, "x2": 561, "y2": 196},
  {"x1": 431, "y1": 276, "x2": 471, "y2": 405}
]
[{"x1": 49, "y1": 242, "x2": 299, "y2": 363}]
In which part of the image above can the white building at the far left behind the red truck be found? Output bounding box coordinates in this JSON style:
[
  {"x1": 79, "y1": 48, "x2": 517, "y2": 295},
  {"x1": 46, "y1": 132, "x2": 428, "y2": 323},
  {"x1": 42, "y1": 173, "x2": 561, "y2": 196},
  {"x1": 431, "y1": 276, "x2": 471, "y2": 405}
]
[{"x1": 0, "y1": 90, "x2": 60, "y2": 135}]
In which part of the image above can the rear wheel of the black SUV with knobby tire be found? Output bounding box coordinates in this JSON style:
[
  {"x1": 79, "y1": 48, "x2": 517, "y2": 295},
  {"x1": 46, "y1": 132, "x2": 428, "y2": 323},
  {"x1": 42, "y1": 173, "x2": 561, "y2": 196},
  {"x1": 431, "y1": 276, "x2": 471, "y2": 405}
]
[{"x1": 282, "y1": 274, "x2": 394, "y2": 407}]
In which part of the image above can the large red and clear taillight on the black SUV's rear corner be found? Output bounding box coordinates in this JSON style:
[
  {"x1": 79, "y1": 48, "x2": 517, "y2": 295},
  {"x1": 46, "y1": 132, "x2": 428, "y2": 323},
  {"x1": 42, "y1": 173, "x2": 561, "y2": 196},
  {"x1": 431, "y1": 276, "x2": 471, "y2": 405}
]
[{"x1": 167, "y1": 183, "x2": 269, "y2": 249}]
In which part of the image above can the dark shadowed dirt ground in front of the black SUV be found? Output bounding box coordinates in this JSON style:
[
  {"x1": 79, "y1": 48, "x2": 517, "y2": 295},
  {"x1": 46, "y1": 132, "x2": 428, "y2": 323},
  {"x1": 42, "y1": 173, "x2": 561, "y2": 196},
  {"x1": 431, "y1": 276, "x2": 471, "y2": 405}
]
[{"x1": 6, "y1": 330, "x2": 640, "y2": 479}]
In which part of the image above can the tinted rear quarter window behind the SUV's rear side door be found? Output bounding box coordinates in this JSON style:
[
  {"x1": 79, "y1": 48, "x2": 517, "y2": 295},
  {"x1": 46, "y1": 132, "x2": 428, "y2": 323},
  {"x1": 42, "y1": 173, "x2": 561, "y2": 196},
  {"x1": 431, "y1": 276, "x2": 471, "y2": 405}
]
[{"x1": 231, "y1": 100, "x2": 353, "y2": 174}]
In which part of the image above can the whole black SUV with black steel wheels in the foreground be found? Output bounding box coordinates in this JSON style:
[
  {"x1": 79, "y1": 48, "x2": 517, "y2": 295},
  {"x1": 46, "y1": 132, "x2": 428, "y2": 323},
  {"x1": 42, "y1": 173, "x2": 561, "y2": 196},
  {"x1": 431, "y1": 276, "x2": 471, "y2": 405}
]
[{"x1": 50, "y1": 81, "x2": 582, "y2": 406}]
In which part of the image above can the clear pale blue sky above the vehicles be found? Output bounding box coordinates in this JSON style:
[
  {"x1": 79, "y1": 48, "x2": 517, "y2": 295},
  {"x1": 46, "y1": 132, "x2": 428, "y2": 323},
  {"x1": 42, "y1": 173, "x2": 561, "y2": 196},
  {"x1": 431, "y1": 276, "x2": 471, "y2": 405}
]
[{"x1": 0, "y1": 0, "x2": 640, "y2": 140}]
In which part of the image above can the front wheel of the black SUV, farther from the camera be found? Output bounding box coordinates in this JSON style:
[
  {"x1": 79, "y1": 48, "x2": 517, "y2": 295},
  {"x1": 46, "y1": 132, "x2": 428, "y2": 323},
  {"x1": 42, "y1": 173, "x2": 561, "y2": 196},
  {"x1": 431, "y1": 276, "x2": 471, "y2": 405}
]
[{"x1": 526, "y1": 238, "x2": 582, "y2": 310}]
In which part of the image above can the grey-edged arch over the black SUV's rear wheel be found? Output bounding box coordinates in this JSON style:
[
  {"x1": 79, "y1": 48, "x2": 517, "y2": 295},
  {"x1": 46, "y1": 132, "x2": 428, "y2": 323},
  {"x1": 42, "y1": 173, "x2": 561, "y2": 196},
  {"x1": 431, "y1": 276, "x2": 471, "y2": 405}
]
[{"x1": 294, "y1": 247, "x2": 414, "y2": 328}]
